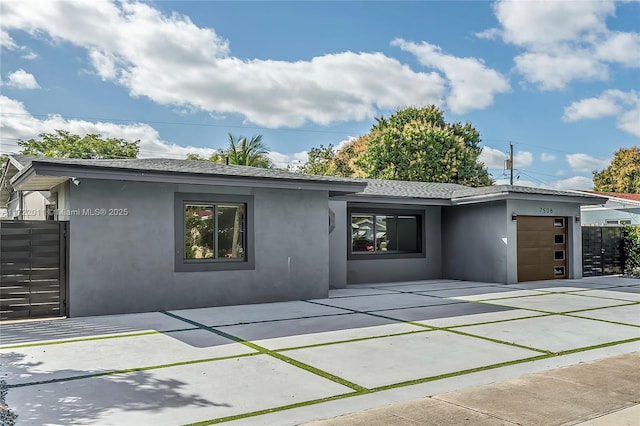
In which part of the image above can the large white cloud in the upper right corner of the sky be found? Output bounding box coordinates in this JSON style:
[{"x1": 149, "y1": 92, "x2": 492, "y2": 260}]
[{"x1": 476, "y1": 0, "x2": 640, "y2": 90}]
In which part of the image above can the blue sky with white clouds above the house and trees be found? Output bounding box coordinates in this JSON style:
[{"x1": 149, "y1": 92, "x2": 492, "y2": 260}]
[{"x1": 0, "y1": 0, "x2": 640, "y2": 189}]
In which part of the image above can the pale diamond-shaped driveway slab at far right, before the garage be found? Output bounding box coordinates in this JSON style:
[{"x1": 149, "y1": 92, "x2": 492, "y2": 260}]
[{"x1": 484, "y1": 293, "x2": 630, "y2": 313}]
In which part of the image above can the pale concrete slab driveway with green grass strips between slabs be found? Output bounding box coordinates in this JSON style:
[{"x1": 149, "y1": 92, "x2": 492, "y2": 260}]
[{"x1": 0, "y1": 277, "x2": 640, "y2": 426}]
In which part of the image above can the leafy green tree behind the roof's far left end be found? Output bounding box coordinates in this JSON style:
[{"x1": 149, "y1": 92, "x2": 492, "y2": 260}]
[{"x1": 18, "y1": 130, "x2": 140, "y2": 159}]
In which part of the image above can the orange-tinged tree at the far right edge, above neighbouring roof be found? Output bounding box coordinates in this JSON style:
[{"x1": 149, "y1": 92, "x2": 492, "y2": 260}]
[{"x1": 593, "y1": 146, "x2": 640, "y2": 194}]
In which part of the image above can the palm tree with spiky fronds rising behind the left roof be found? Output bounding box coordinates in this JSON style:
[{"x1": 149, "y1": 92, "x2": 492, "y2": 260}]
[{"x1": 187, "y1": 133, "x2": 273, "y2": 168}]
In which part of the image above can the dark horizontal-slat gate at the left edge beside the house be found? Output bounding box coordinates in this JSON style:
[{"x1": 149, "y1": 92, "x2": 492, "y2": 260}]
[{"x1": 0, "y1": 220, "x2": 67, "y2": 319}]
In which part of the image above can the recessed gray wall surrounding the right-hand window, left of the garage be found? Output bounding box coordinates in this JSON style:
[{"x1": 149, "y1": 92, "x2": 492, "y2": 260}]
[{"x1": 329, "y1": 201, "x2": 442, "y2": 288}]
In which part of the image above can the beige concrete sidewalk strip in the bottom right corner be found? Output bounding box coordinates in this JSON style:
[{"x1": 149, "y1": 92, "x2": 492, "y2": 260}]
[{"x1": 307, "y1": 352, "x2": 640, "y2": 426}]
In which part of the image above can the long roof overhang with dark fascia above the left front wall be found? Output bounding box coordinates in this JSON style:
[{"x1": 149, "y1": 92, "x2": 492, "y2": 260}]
[{"x1": 11, "y1": 160, "x2": 366, "y2": 195}]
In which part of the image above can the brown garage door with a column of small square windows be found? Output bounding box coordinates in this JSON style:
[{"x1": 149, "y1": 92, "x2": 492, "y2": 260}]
[{"x1": 517, "y1": 216, "x2": 567, "y2": 281}]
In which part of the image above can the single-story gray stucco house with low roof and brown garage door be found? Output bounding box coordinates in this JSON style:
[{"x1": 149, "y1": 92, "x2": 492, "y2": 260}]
[{"x1": 0, "y1": 155, "x2": 602, "y2": 316}]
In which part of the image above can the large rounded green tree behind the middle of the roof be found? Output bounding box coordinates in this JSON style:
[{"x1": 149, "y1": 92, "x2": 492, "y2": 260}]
[{"x1": 356, "y1": 105, "x2": 492, "y2": 186}]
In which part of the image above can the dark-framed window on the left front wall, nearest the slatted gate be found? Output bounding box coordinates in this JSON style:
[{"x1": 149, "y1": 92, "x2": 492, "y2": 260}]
[{"x1": 175, "y1": 193, "x2": 254, "y2": 271}]
